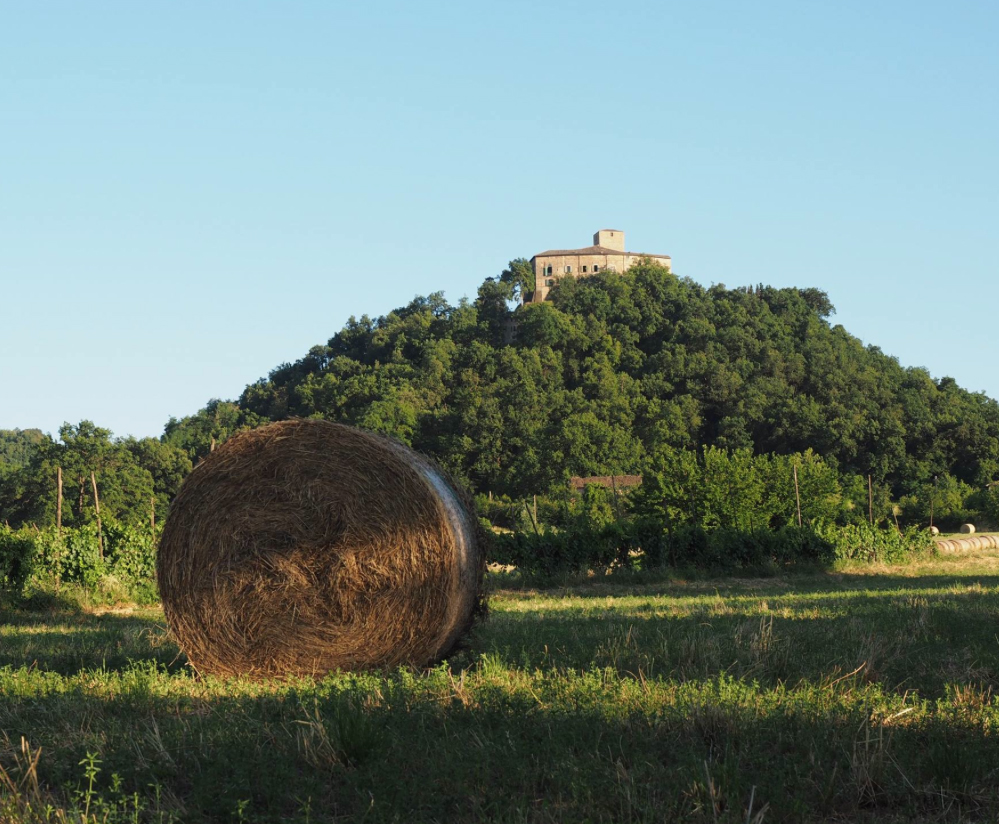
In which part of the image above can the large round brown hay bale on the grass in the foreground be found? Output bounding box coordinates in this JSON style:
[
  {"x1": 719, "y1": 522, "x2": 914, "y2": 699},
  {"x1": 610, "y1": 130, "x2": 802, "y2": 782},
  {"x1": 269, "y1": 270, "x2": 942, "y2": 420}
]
[{"x1": 156, "y1": 420, "x2": 485, "y2": 677}]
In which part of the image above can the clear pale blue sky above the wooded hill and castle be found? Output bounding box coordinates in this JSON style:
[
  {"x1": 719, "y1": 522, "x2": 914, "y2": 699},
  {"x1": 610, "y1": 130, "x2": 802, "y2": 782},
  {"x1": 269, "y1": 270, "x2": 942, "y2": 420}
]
[{"x1": 0, "y1": 0, "x2": 999, "y2": 436}]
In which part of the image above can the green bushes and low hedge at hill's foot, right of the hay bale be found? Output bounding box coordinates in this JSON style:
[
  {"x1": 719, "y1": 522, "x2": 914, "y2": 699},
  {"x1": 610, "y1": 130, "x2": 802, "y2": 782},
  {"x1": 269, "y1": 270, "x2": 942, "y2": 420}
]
[{"x1": 477, "y1": 447, "x2": 940, "y2": 576}]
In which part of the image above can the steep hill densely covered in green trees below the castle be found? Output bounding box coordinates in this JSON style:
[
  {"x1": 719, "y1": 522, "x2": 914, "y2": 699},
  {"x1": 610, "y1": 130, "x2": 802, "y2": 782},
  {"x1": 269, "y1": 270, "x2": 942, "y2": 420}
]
[{"x1": 165, "y1": 261, "x2": 999, "y2": 495}]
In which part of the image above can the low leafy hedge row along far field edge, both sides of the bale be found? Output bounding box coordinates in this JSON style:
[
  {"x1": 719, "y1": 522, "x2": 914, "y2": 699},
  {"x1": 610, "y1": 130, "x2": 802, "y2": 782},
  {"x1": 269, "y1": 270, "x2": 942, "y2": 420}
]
[{"x1": 0, "y1": 517, "x2": 933, "y2": 594}]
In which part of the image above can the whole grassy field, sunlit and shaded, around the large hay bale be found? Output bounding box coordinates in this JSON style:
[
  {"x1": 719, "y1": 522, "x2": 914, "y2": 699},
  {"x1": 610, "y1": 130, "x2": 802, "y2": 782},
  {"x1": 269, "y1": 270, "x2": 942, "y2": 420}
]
[{"x1": 0, "y1": 552, "x2": 999, "y2": 822}]
